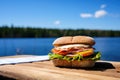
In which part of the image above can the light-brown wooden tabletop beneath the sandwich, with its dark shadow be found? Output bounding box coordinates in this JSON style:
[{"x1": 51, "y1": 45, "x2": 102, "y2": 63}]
[{"x1": 0, "y1": 61, "x2": 120, "y2": 80}]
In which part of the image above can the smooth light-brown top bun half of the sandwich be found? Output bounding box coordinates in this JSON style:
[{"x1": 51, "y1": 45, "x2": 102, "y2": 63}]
[{"x1": 53, "y1": 36, "x2": 95, "y2": 47}]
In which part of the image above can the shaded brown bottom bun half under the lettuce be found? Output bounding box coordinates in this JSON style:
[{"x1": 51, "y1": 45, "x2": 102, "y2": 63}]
[{"x1": 52, "y1": 59, "x2": 95, "y2": 68}]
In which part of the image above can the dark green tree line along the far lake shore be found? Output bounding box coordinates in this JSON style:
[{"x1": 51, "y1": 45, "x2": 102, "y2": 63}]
[{"x1": 0, "y1": 26, "x2": 120, "y2": 38}]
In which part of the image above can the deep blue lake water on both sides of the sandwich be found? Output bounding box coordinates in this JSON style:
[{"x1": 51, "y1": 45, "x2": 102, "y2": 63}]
[{"x1": 0, "y1": 37, "x2": 120, "y2": 61}]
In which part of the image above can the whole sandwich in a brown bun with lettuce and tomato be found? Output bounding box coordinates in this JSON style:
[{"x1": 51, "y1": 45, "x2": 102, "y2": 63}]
[{"x1": 48, "y1": 36, "x2": 101, "y2": 68}]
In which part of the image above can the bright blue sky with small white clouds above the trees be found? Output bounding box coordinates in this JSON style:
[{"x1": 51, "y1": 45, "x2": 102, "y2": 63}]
[{"x1": 0, "y1": 0, "x2": 120, "y2": 30}]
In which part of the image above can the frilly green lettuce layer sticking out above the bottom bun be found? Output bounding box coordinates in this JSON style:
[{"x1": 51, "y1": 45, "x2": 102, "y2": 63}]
[{"x1": 48, "y1": 52, "x2": 101, "y2": 61}]
